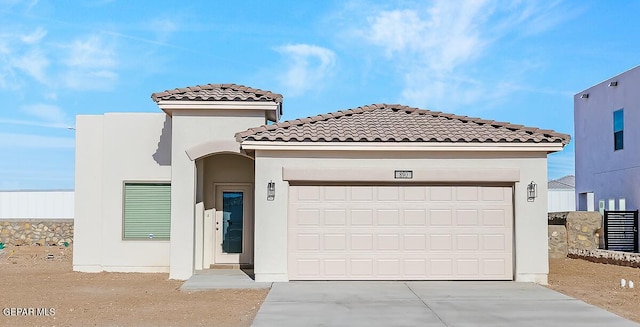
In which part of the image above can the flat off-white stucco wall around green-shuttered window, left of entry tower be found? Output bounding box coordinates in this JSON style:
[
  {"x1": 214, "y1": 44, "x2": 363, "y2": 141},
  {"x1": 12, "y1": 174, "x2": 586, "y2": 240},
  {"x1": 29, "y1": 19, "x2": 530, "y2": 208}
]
[{"x1": 73, "y1": 113, "x2": 171, "y2": 272}]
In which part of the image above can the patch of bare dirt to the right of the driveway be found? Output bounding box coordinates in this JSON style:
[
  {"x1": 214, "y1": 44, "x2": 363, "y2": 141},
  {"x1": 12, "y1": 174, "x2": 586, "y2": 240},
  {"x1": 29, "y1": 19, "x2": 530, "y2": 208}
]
[{"x1": 549, "y1": 258, "x2": 640, "y2": 323}]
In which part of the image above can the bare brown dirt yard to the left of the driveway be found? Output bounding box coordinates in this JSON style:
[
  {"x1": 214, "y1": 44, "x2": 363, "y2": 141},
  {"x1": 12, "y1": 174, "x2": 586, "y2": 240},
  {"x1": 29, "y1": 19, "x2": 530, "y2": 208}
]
[{"x1": 0, "y1": 246, "x2": 268, "y2": 326}]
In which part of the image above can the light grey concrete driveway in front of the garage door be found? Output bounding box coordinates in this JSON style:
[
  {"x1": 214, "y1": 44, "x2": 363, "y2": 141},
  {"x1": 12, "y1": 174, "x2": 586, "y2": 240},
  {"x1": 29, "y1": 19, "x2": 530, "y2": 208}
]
[{"x1": 253, "y1": 281, "x2": 640, "y2": 327}]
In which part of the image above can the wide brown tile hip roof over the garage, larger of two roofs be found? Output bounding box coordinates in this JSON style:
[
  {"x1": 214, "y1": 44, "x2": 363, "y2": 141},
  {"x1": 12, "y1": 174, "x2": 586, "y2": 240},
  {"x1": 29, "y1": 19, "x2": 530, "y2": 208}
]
[{"x1": 236, "y1": 104, "x2": 571, "y2": 145}]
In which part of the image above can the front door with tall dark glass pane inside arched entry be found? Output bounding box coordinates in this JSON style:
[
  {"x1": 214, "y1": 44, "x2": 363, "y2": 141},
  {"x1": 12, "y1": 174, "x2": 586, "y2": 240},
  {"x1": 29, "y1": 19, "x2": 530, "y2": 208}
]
[{"x1": 214, "y1": 184, "x2": 253, "y2": 264}]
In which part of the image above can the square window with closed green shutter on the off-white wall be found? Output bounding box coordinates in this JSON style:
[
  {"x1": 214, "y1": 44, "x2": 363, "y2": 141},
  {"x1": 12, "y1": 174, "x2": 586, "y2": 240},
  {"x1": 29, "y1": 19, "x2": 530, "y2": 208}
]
[{"x1": 122, "y1": 182, "x2": 171, "y2": 240}]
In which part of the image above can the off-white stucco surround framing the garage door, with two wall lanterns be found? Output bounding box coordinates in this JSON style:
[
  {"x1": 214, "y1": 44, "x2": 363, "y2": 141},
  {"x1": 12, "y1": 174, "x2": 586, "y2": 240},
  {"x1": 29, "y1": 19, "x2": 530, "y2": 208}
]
[{"x1": 254, "y1": 150, "x2": 549, "y2": 284}]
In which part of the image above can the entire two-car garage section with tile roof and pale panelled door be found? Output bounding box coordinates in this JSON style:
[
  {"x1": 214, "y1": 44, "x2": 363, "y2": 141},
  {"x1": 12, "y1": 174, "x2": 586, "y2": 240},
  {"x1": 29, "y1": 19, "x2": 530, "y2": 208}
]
[{"x1": 237, "y1": 104, "x2": 570, "y2": 284}]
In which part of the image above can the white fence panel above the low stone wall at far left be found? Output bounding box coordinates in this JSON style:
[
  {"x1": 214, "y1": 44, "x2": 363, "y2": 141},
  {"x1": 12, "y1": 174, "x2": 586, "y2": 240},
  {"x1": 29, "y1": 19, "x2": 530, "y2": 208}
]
[{"x1": 0, "y1": 190, "x2": 74, "y2": 219}]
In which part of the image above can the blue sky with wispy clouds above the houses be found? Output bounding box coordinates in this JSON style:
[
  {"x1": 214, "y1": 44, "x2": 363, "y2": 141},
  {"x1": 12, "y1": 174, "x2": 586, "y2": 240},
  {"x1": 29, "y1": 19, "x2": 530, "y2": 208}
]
[{"x1": 0, "y1": 0, "x2": 640, "y2": 190}]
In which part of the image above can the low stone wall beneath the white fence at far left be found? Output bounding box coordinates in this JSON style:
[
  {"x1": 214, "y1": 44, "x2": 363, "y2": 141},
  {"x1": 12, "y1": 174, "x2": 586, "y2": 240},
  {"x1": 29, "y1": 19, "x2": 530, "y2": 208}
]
[{"x1": 0, "y1": 219, "x2": 73, "y2": 246}]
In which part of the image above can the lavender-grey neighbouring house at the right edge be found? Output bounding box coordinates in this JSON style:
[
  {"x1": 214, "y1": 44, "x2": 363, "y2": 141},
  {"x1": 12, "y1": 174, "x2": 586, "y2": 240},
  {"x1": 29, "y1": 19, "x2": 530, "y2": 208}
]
[{"x1": 574, "y1": 66, "x2": 640, "y2": 211}]
